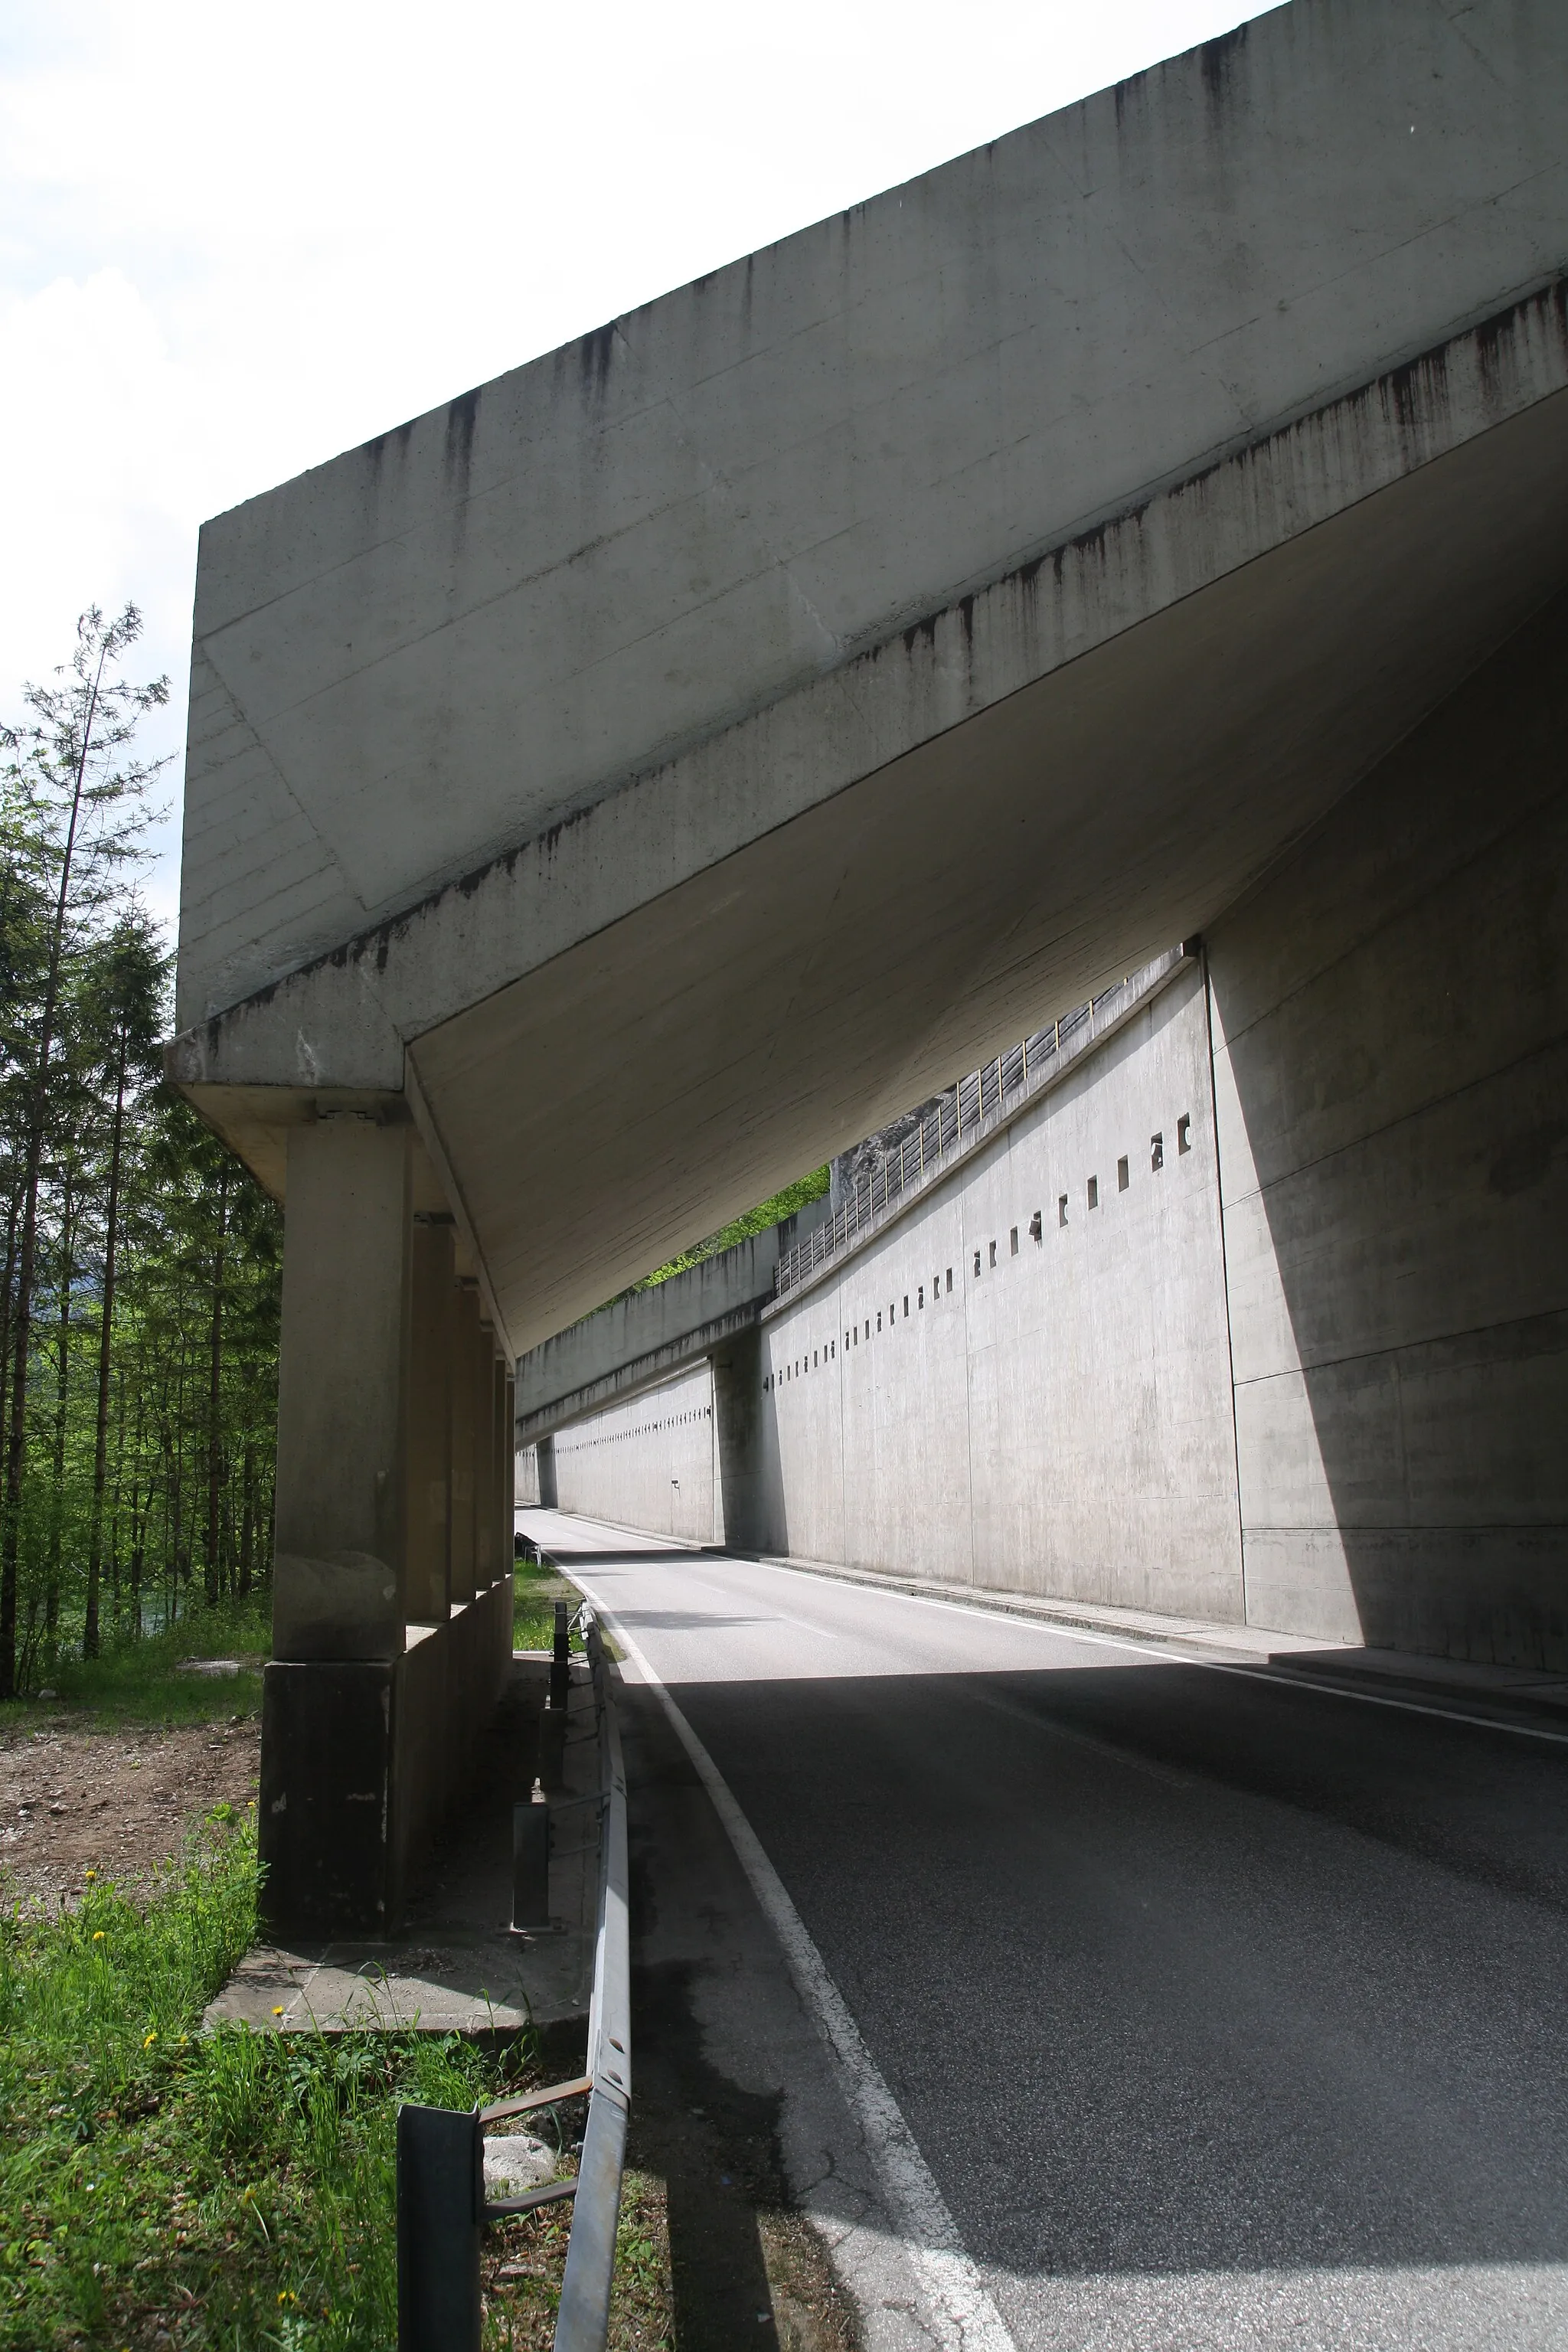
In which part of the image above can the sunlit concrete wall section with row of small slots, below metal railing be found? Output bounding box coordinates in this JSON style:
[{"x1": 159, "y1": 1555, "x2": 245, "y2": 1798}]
[{"x1": 762, "y1": 967, "x2": 1241, "y2": 1619}]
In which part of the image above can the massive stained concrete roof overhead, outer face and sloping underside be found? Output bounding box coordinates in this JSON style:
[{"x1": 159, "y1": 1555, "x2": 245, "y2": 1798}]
[{"x1": 176, "y1": 0, "x2": 1568, "y2": 1350}]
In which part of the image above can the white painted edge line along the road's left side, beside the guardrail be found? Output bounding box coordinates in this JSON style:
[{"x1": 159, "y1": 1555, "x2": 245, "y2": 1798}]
[{"x1": 562, "y1": 1564, "x2": 1018, "y2": 2352}]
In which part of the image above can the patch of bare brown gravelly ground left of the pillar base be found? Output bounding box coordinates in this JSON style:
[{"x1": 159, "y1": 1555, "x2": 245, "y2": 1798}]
[{"x1": 0, "y1": 1717, "x2": 261, "y2": 1903}]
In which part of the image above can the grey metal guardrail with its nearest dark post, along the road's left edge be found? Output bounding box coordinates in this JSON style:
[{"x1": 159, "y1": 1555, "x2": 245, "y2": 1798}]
[{"x1": 397, "y1": 1606, "x2": 632, "y2": 2352}]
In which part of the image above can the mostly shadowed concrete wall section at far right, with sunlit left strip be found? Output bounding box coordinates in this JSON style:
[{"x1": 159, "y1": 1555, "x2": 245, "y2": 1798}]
[{"x1": 1210, "y1": 588, "x2": 1568, "y2": 1665}]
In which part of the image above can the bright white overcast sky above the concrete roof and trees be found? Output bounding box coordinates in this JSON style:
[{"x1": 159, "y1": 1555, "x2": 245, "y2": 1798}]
[{"x1": 0, "y1": 0, "x2": 1258, "y2": 936}]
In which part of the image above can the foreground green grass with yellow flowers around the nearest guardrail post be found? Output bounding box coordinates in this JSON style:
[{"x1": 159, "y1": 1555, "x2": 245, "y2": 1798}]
[{"x1": 0, "y1": 1806, "x2": 668, "y2": 2352}]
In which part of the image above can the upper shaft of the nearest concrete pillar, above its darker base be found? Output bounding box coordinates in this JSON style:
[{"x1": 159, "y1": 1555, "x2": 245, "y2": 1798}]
[{"x1": 273, "y1": 1115, "x2": 411, "y2": 1658}]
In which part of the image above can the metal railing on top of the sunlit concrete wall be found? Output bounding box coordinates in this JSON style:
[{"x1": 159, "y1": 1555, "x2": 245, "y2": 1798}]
[{"x1": 773, "y1": 948, "x2": 1185, "y2": 1298}]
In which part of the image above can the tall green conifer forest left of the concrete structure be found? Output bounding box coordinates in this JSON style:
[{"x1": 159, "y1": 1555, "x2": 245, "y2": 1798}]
[{"x1": 0, "y1": 605, "x2": 282, "y2": 1698}]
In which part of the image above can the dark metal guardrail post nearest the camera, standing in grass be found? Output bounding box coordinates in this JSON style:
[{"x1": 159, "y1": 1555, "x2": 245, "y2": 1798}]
[{"x1": 397, "y1": 2108, "x2": 485, "y2": 2352}]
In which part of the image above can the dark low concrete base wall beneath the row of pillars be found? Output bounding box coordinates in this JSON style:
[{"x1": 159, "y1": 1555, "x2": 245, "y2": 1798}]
[{"x1": 259, "y1": 1576, "x2": 512, "y2": 1938}]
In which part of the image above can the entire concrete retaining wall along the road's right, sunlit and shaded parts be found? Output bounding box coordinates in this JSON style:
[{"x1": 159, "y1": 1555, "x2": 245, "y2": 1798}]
[{"x1": 531, "y1": 597, "x2": 1568, "y2": 1668}]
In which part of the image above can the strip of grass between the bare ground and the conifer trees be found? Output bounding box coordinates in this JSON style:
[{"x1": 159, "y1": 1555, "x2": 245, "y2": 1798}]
[{"x1": 0, "y1": 1592, "x2": 273, "y2": 1731}]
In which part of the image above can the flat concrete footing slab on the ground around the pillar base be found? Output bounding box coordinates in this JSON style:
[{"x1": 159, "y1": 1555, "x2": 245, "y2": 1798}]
[{"x1": 202, "y1": 1651, "x2": 599, "y2": 2037}]
